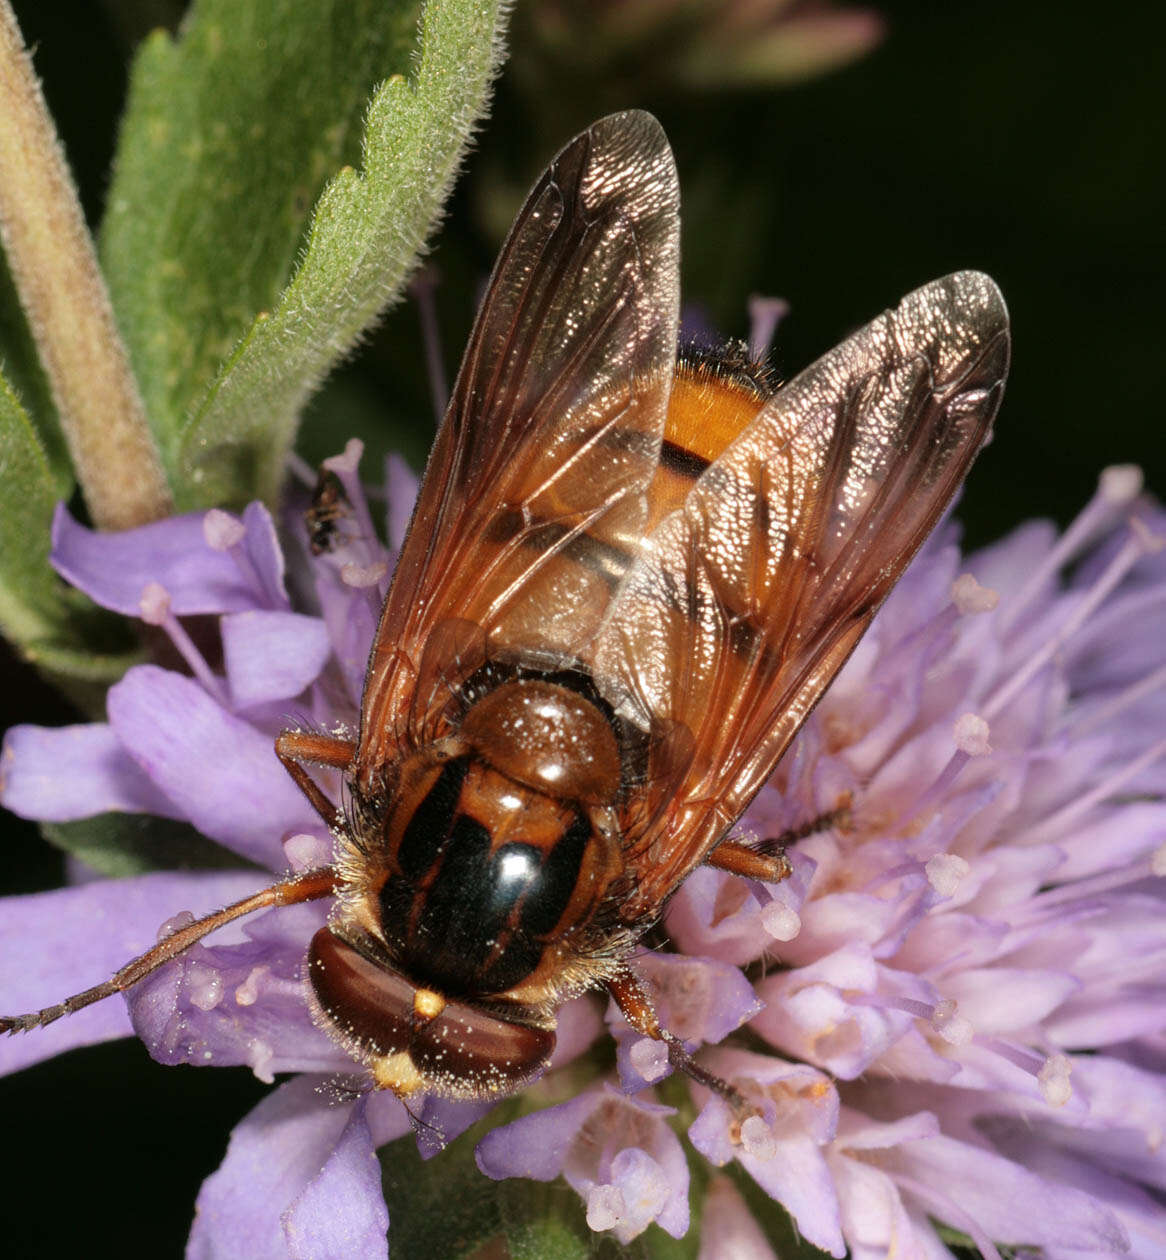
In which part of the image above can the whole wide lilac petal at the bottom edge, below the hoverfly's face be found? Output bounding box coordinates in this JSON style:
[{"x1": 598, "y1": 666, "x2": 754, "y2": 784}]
[{"x1": 187, "y1": 1076, "x2": 403, "y2": 1260}]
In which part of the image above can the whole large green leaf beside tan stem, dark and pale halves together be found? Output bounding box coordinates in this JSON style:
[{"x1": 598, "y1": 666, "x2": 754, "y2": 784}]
[{"x1": 102, "y1": 0, "x2": 505, "y2": 508}]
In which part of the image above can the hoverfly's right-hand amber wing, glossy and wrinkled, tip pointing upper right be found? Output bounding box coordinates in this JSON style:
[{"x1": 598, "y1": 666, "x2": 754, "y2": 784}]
[{"x1": 594, "y1": 272, "x2": 1008, "y2": 919}]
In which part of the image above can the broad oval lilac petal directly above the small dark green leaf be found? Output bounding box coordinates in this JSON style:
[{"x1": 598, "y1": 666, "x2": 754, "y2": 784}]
[{"x1": 106, "y1": 665, "x2": 320, "y2": 869}]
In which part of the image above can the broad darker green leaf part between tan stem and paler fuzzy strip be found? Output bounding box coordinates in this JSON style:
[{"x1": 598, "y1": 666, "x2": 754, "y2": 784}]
[{"x1": 101, "y1": 0, "x2": 420, "y2": 474}]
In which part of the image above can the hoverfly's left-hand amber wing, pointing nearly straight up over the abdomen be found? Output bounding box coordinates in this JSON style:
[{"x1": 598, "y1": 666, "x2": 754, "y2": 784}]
[{"x1": 357, "y1": 111, "x2": 679, "y2": 776}]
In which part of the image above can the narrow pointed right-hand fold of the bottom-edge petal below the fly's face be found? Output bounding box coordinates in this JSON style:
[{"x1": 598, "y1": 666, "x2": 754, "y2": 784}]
[{"x1": 282, "y1": 1103, "x2": 388, "y2": 1260}]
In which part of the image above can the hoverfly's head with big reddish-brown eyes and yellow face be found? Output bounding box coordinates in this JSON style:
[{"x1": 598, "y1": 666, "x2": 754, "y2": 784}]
[{"x1": 308, "y1": 927, "x2": 555, "y2": 1099}]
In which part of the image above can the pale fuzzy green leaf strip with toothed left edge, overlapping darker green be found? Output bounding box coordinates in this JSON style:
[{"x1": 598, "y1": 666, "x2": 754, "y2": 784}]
[{"x1": 183, "y1": 0, "x2": 508, "y2": 504}]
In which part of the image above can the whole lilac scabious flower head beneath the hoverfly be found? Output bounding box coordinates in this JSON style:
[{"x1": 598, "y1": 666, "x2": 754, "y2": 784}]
[{"x1": 0, "y1": 444, "x2": 1166, "y2": 1260}]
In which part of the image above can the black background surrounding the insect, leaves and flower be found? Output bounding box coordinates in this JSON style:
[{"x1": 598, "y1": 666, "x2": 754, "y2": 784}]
[{"x1": 0, "y1": 0, "x2": 1166, "y2": 1255}]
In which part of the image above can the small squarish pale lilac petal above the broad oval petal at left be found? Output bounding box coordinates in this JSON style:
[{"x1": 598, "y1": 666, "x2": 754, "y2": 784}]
[{"x1": 219, "y1": 610, "x2": 332, "y2": 708}]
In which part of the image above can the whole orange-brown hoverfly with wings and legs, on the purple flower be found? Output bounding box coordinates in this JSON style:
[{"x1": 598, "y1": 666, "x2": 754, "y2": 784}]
[{"x1": 3, "y1": 112, "x2": 1008, "y2": 1099}]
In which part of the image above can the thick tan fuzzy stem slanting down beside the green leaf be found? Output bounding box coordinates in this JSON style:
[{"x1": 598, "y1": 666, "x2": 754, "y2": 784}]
[{"x1": 0, "y1": 0, "x2": 173, "y2": 529}]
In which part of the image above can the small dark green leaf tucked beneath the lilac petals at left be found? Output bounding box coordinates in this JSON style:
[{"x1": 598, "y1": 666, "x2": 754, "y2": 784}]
[{"x1": 40, "y1": 814, "x2": 250, "y2": 878}]
